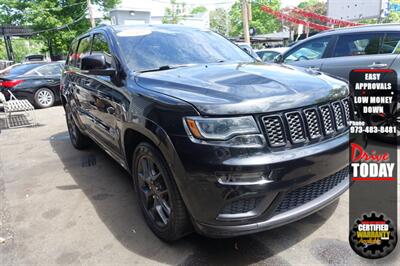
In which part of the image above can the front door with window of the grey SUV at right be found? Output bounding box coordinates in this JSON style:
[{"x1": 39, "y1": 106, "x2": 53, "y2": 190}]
[{"x1": 283, "y1": 36, "x2": 333, "y2": 70}]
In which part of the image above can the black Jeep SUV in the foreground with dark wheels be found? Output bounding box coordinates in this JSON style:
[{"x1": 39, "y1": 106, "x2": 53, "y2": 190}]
[{"x1": 61, "y1": 25, "x2": 351, "y2": 240}]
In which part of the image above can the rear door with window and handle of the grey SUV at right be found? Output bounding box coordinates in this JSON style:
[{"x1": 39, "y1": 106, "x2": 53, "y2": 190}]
[{"x1": 321, "y1": 32, "x2": 400, "y2": 80}]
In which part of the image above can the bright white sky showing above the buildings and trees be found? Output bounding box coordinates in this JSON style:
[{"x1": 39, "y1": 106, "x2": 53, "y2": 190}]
[{"x1": 120, "y1": 0, "x2": 302, "y2": 16}]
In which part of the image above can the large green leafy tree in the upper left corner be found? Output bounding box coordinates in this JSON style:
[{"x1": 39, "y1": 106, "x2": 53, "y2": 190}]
[{"x1": 0, "y1": 0, "x2": 119, "y2": 59}]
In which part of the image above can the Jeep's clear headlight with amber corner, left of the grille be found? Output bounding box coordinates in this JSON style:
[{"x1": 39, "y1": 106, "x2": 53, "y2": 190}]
[{"x1": 185, "y1": 116, "x2": 260, "y2": 140}]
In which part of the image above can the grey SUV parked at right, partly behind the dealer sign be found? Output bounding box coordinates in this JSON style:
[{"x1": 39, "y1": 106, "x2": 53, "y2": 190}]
[{"x1": 277, "y1": 24, "x2": 400, "y2": 143}]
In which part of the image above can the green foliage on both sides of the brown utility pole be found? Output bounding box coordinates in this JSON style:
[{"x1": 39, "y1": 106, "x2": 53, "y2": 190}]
[{"x1": 229, "y1": 0, "x2": 281, "y2": 36}]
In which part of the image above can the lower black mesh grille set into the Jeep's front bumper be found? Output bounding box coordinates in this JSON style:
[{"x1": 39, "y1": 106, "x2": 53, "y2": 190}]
[{"x1": 274, "y1": 167, "x2": 349, "y2": 215}]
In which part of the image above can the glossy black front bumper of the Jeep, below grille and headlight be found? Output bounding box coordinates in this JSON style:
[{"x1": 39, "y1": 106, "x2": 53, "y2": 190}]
[{"x1": 171, "y1": 133, "x2": 349, "y2": 237}]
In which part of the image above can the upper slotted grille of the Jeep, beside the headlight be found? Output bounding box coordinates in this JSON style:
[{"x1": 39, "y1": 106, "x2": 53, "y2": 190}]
[{"x1": 262, "y1": 98, "x2": 351, "y2": 147}]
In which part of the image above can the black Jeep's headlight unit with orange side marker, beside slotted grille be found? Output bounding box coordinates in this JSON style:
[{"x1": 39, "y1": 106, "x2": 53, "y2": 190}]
[{"x1": 184, "y1": 116, "x2": 265, "y2": 146}]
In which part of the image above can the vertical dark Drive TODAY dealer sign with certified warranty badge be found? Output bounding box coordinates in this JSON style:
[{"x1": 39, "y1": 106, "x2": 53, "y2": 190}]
[{"x1": 349, "y1": 69, "x2": 399, "y2": 258}]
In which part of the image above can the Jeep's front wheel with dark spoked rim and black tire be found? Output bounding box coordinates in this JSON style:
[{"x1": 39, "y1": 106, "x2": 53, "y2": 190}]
[{"x1": 132, "y1": 142, "x2": 192, "y2": 242}]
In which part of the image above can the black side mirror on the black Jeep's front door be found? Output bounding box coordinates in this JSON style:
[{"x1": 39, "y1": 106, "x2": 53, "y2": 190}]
[{"x1": 81, "y1": 54, "x2": 115, "y2": 76}]
